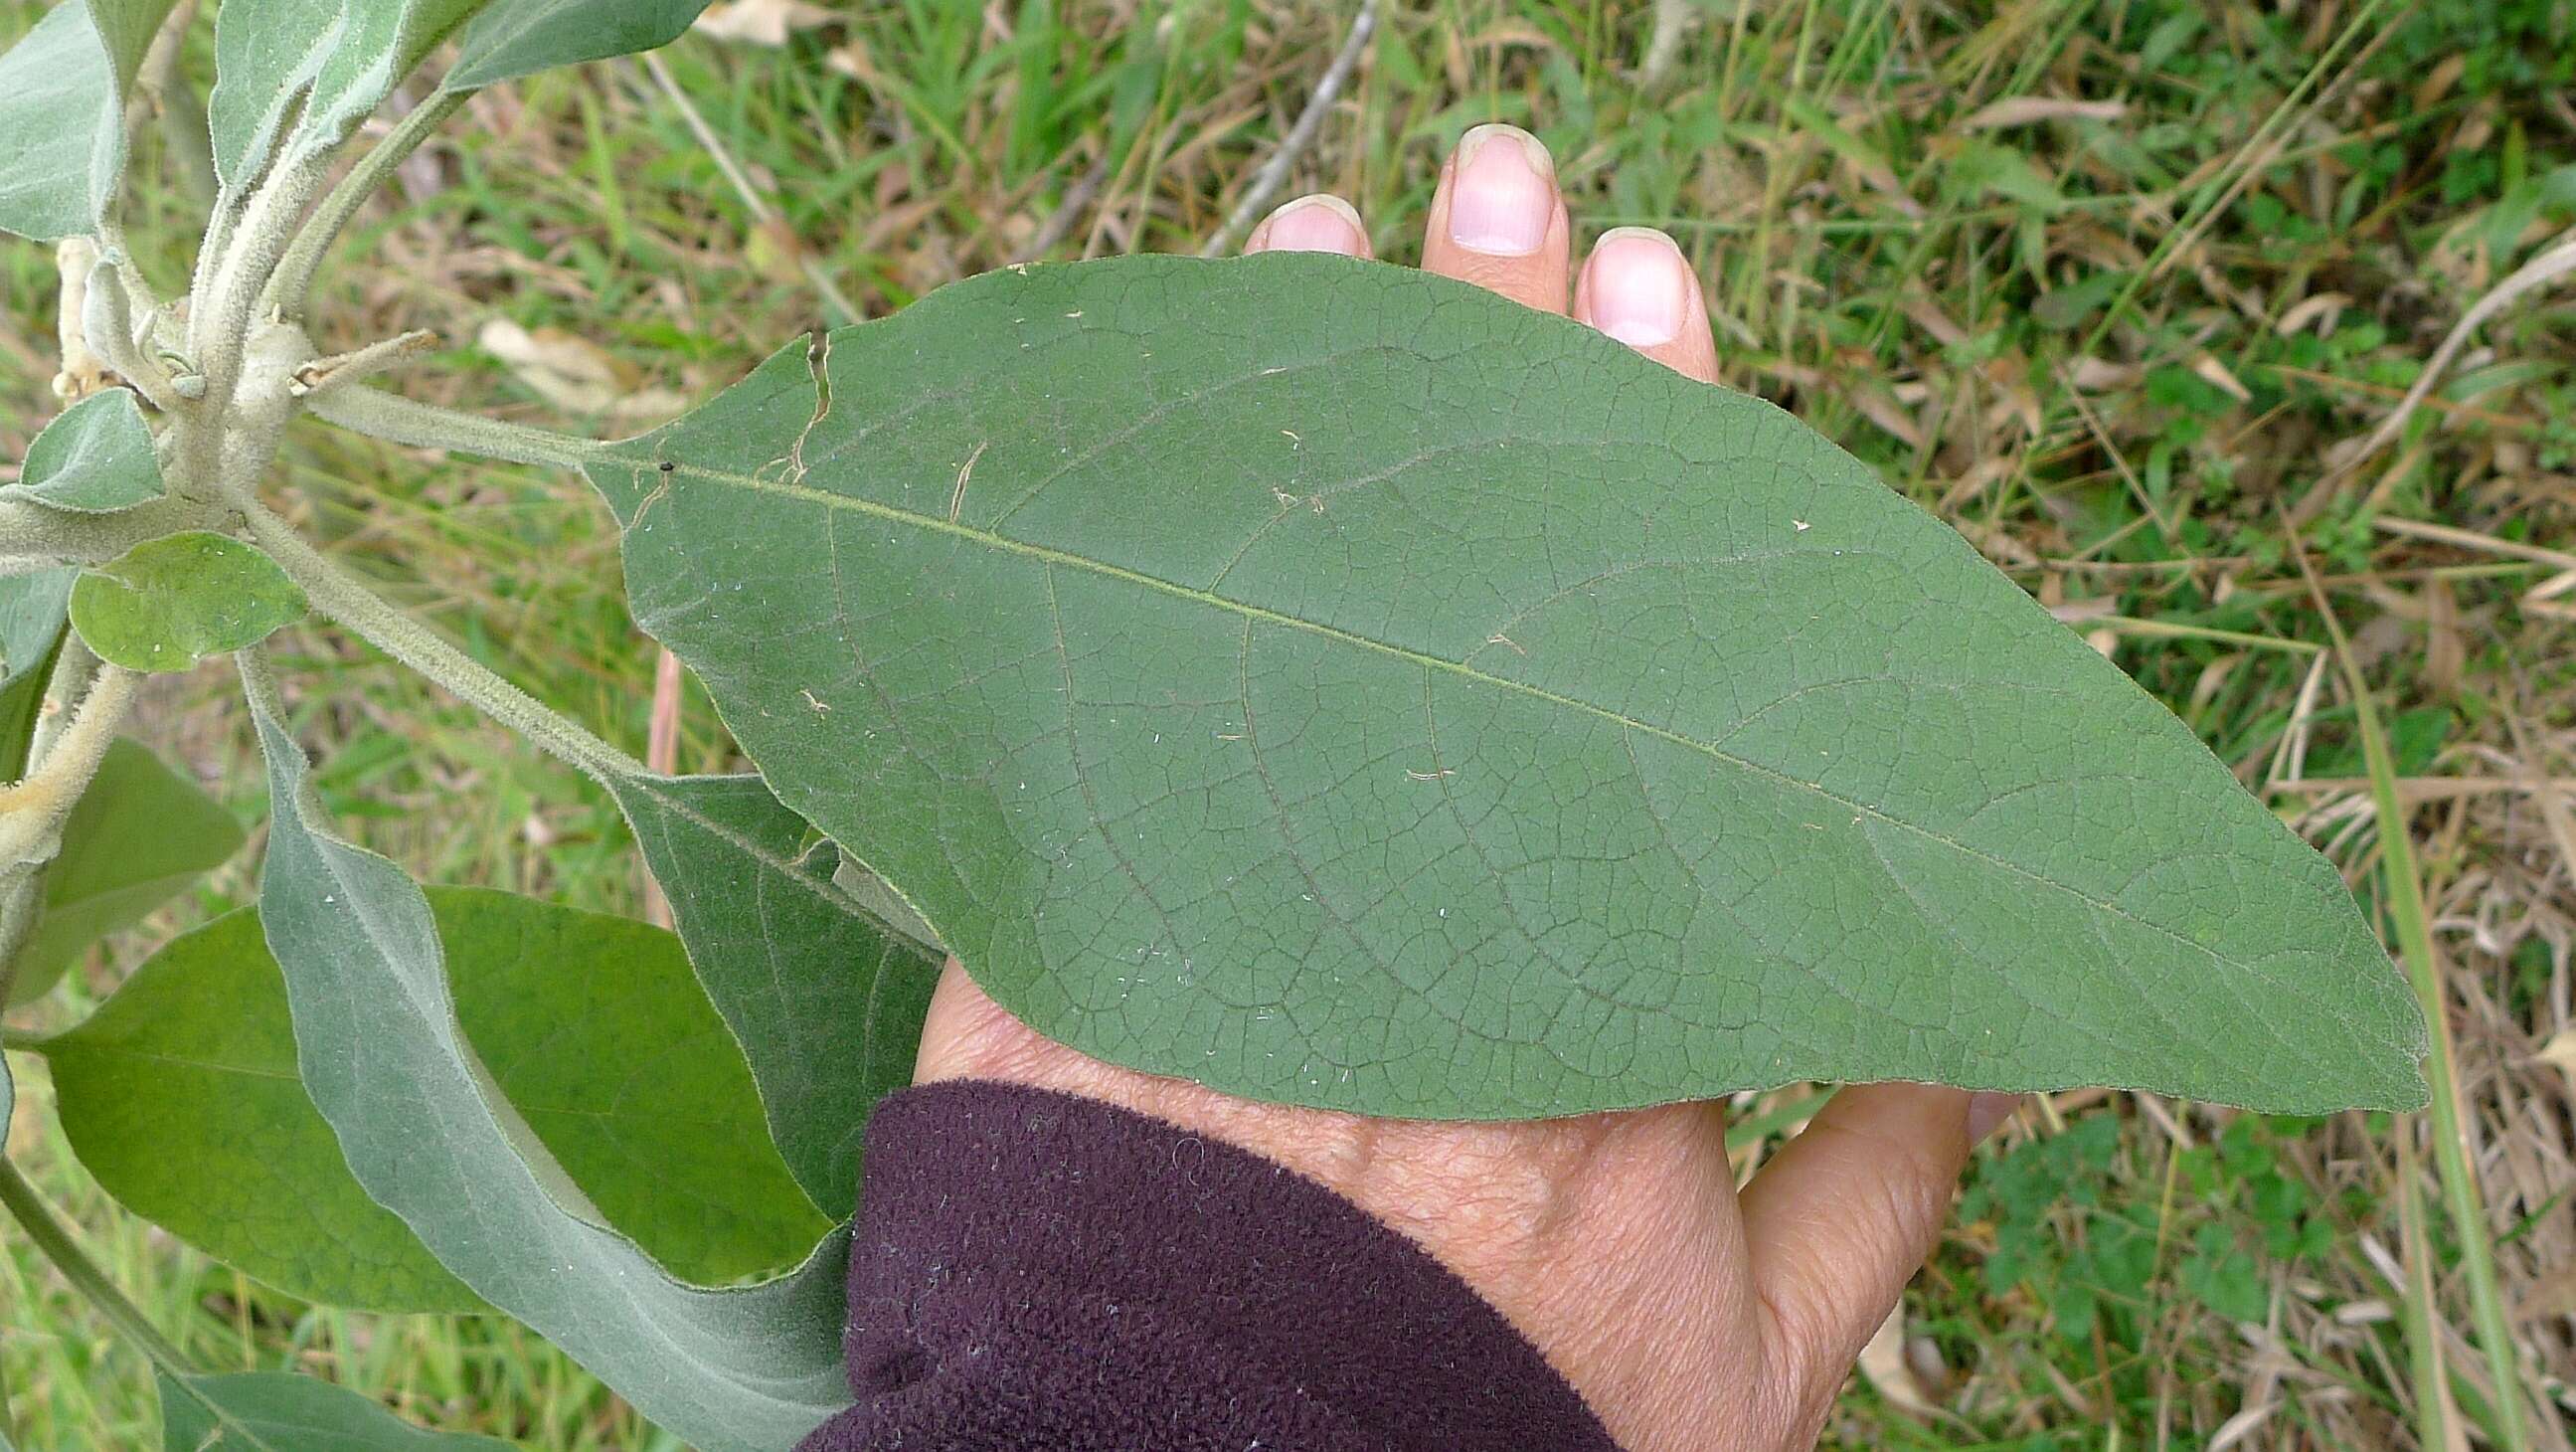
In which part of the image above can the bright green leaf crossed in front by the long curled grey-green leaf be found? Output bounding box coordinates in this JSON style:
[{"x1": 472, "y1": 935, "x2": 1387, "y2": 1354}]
[{"x1": 44, "y1": 887, "x2": 829, "y2": 1310}]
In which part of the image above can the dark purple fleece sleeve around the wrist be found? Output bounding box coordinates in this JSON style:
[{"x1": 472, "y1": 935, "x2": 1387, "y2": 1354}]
[{"x1": 803, "y1": 1081, "x2": 1618, "y2": 1452}]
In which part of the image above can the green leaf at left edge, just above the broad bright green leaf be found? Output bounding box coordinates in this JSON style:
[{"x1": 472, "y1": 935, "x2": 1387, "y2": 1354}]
[{"x1": 10, "y1": 740, "x2": 243, "y2": 1005}]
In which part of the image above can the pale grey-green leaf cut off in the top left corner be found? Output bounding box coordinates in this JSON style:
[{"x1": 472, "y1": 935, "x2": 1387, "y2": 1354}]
[{"x1": 0, "y1": 0, "x2": 173, "y2": 243}]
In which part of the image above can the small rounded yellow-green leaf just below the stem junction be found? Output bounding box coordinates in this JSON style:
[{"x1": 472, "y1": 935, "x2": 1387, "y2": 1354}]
[{"x1": 73, "y1": 529, "x2": 304, "y2": 670}]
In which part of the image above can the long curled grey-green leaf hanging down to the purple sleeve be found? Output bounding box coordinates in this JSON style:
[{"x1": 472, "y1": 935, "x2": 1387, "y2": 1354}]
[{"x1": 253, "y1": 685, "x2": 850, "y2": 1452}]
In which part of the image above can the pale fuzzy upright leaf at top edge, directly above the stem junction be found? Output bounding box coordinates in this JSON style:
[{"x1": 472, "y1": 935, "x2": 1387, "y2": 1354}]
[{"x1": 206, "y1": 0, "x2": 484, "y2": 191}]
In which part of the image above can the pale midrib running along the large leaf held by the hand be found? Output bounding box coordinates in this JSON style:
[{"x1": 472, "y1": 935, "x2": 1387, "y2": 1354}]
[{"x1": 617, "y1": 449, "x2": 2298, "y2": 985}]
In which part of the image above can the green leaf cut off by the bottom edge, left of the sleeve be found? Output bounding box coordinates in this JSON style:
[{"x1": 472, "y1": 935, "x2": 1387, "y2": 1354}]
[{"x1": 154, "y1": 1372, "x2": 510, "y2": 1452}]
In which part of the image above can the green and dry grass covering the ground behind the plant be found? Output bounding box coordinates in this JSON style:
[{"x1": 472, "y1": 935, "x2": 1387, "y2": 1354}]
[{"x1": 0, "y1": 0, "x2": 2576, "y2": 1449}]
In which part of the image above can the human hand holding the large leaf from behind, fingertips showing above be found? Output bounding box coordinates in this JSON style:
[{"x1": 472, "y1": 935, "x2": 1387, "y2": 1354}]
[{"x1": 915, "y1": 126, "x2": 2012, "y2": 1452}]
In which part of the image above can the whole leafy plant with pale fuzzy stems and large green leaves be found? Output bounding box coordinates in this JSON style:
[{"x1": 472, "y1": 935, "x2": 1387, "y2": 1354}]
[{"x1": 0, "y1": 0, "x2": 2424, "y2": 1452}]
